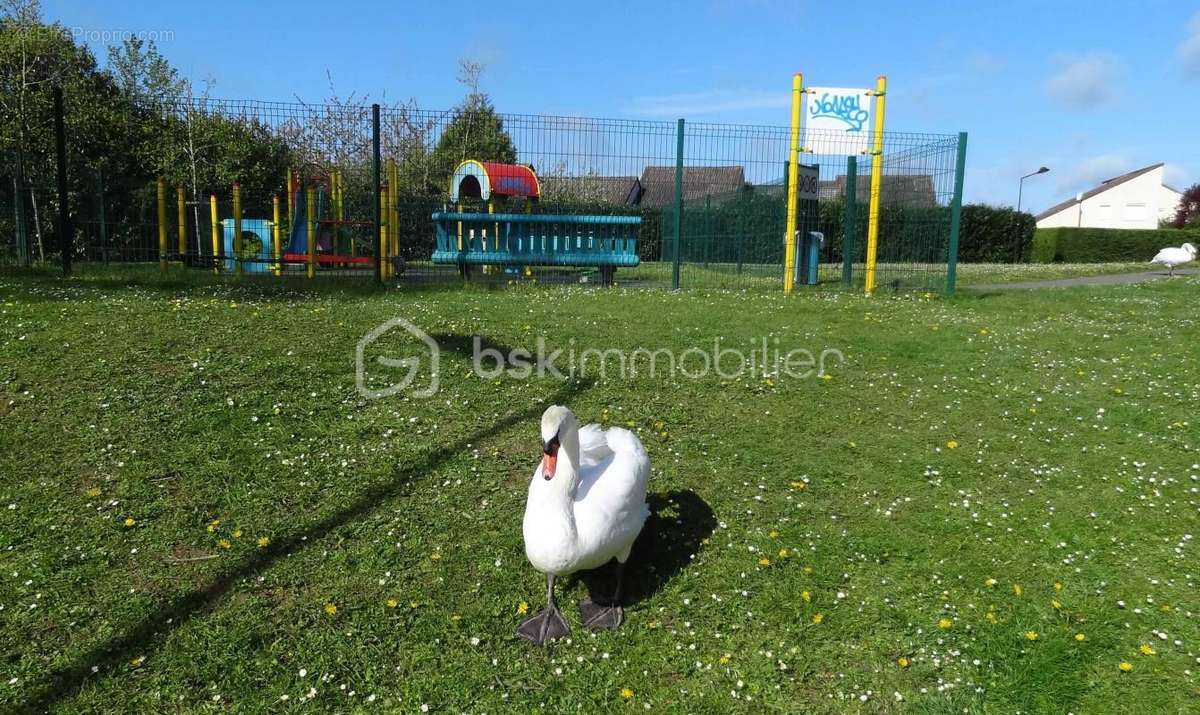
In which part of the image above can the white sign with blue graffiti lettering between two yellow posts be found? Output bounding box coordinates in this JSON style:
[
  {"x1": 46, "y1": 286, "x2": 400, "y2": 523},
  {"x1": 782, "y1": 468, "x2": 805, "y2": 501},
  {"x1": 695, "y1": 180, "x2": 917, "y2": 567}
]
[{"x1": 802, "y1": 86, "x2": 874, "y2": 156}]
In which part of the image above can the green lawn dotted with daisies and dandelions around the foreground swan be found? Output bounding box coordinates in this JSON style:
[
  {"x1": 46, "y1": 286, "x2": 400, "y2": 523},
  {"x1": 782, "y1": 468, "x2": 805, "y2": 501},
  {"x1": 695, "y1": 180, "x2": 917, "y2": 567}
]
[{"x1": 0, "y1": 265, "x2": 1200, "y2": 714}]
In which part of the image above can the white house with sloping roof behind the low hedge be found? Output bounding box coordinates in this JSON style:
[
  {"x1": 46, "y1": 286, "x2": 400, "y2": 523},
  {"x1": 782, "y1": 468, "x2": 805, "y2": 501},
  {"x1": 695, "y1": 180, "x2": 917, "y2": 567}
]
[{"x1": 1034, "y1": 163, "x2": 1183, "y2": 228}]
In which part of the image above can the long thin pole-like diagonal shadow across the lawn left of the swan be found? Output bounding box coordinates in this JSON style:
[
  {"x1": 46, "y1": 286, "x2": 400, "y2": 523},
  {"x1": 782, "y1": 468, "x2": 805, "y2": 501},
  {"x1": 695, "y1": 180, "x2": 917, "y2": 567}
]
[{"x1": 20, "y1": 335, "x2": 592, "y2": 713}]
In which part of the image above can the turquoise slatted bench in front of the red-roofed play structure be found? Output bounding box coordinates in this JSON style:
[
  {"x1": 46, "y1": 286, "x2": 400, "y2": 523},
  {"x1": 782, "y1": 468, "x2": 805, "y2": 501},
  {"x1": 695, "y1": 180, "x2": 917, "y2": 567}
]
[{"x1": 433, "y1": 211, "x2": 642, "y2": 286}]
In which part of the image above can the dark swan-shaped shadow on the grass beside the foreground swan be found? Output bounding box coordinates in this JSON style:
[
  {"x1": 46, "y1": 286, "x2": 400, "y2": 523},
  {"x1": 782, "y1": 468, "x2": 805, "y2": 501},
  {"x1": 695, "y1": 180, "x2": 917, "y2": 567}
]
[{"x1": 577, "y1": 489, "x2": 716, "y2": 608}]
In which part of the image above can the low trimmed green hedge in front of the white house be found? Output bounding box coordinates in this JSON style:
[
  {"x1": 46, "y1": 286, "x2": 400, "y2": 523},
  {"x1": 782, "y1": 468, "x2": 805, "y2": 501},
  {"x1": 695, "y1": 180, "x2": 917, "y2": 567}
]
[{"x1": 1032, "y1": 227, "x2": 1200, "y2": 263}]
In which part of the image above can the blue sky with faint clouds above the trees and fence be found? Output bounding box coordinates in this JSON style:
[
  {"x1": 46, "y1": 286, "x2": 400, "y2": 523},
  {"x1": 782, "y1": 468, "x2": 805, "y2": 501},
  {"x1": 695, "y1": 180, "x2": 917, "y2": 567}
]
[{"x1": 43, "y1": 0, "x2": 1200, "y2": 211}]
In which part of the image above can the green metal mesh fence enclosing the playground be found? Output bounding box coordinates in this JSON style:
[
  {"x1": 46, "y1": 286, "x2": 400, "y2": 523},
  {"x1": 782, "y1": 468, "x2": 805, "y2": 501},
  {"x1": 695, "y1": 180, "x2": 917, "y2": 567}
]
[{"x1": 0, "y1": 92, "x2": 965, "y2": 290}]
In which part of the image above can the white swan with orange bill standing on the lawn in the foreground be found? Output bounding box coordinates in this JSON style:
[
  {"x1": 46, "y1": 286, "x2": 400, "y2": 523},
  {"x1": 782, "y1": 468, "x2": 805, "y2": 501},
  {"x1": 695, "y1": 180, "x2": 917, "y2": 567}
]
[{"x1": 517, "y1": 404, "x2": 650, "y2": 644}]
